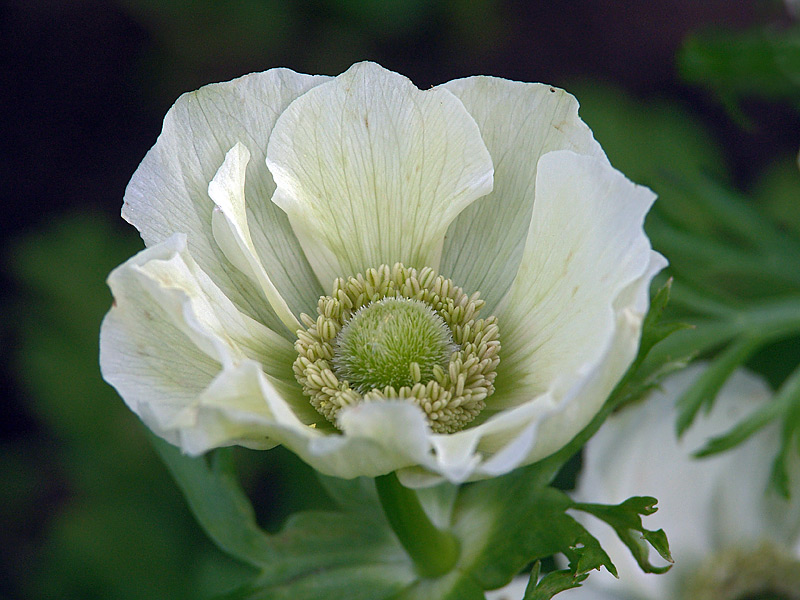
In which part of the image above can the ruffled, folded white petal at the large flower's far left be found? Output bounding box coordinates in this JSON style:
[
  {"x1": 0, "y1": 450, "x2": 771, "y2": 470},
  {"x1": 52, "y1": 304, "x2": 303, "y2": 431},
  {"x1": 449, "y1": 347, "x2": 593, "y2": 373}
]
[{"x1": 100, "y1": 234, "x2": 310, "y2": 449}]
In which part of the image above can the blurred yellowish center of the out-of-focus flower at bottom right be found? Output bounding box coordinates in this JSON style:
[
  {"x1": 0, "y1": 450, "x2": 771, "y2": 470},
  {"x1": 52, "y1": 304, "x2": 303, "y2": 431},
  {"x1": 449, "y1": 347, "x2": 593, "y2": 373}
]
[{"x1": 683, "y1": 542, "x2": 800, "y2": 600}]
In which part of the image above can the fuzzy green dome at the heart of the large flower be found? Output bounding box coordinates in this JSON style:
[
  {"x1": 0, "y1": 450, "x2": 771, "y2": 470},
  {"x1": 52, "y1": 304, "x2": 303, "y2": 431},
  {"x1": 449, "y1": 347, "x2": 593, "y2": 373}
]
[{"x1": 333, "y1": 298, "x2": 457, "y2": 394}]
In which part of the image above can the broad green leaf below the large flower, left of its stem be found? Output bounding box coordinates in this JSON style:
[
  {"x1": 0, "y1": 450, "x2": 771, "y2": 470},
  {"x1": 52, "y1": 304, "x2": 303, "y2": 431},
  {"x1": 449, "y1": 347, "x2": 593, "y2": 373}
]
[{"x1": 153, "y1": 438, "x2": 416, "y2": 600}]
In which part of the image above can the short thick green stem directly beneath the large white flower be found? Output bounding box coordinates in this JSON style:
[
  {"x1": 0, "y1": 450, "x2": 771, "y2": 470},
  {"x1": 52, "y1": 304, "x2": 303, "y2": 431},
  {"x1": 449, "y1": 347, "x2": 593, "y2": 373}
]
[{"x1": 375, "y1": 473, "x2": 459, "y2": 577}]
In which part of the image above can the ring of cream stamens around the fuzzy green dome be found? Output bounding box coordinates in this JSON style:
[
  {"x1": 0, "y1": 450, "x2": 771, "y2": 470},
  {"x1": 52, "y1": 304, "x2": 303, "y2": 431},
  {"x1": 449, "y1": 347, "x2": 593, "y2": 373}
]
[{"x1": 294, "y1": 263, "x2": 500, "y2": 433}]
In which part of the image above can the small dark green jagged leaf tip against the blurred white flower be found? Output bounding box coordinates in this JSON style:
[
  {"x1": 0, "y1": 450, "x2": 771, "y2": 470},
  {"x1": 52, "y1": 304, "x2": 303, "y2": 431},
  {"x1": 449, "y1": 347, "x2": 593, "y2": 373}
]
[{"x1": 574, "y1": 496, "x2": 674, "y2": 573}]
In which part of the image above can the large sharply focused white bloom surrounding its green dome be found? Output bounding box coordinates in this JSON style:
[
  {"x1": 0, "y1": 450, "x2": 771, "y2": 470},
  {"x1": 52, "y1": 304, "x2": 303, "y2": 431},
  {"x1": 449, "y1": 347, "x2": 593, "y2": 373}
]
[{"x1": 100, "y1": 63, "x2": 665, "y2": 485}]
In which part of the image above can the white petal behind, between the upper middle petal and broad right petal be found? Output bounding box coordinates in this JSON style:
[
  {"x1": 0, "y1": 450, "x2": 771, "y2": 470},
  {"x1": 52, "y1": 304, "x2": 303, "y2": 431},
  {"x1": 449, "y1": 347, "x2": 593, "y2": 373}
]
[{"x1": 441, "y1": 77, "x2": 604, "y2": 314}]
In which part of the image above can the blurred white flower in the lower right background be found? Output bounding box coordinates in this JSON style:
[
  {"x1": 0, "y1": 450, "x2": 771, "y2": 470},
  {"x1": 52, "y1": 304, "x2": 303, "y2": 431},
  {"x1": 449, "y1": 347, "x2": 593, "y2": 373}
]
[{"x1": 559, "y1": 367, "x2": 800, "y2": 600}]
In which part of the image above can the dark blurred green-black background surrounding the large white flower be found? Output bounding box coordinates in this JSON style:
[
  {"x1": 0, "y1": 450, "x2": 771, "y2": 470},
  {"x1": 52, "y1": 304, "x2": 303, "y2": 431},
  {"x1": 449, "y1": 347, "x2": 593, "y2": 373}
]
[{"x1": 0, "y1": 0, "x2": 800, "y2": 600}]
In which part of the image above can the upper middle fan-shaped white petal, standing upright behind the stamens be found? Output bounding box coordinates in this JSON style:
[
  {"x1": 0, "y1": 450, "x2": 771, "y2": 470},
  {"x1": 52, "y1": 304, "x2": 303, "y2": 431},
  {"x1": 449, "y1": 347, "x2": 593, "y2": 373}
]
[{"x1": 267, "y1": 63, "x2": 492, "y2": 289}]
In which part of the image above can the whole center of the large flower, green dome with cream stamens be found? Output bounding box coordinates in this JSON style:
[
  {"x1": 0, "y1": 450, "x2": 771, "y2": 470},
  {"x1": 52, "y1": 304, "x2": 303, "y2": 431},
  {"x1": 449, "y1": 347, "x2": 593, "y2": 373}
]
[{"x1": 293, "y1": 263, "x2": 500, "y2": 433}]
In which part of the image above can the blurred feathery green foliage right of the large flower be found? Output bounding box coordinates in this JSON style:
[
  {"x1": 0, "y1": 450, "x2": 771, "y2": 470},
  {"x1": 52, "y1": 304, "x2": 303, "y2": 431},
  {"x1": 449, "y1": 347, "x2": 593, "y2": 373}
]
[{"x1": 577, "y1": 75, "x2": 800, "y2": 494}]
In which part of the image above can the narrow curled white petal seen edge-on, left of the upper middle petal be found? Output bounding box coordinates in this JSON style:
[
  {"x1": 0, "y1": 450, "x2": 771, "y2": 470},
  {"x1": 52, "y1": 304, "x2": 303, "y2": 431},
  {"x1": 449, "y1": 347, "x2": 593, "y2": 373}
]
[{"x1": 208, "y1": 142, "x2": 300, "y2": 331}]
